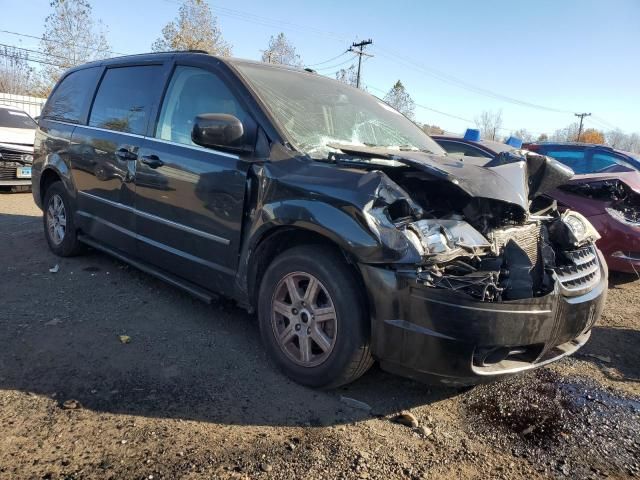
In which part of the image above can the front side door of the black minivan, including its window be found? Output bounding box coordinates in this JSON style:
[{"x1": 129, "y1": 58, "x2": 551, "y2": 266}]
[{"x1": 135, "y1": 65, "x2": 252, "y2": 293}]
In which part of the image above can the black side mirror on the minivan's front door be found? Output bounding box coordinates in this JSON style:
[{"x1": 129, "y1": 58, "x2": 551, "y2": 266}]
[{"x1": 191, "y1": 113, "x2": 248, "y2": 151}]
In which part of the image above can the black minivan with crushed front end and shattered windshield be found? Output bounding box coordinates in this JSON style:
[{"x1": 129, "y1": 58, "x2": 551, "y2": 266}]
[{"x1": 33, "y1": 52, "x2": 607, "y2": 387}]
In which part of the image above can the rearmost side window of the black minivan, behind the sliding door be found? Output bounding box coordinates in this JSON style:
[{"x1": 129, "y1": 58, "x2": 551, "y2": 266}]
[{"x1": 42, "y1": 67, "x2": 100, "y2": 123}]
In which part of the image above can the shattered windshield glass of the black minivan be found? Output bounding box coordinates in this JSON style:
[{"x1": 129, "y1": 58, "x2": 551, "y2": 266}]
[{"x1": 237, "y1": 63, "x2": 445, "y2": 158}]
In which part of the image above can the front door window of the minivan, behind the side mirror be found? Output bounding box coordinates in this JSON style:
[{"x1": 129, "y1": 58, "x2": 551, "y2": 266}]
[{"x1": 155, "y1": 66, "x2": 247, "y2": 145}]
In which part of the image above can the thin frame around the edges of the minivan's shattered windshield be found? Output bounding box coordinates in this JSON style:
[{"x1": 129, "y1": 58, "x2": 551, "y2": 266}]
[{"x1": 228, "y1": 59, "x2": 447, "y2": 158}]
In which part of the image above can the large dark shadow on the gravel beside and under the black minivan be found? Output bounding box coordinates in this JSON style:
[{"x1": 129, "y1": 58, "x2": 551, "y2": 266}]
[{"x1": 0, "y1": 232, "x2": 458, "y2": 426}]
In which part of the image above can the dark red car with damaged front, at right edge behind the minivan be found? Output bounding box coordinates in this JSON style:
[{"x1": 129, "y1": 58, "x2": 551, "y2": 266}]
[{"x1": 525, "y1": 142, "x2": 640, "y2": 274}]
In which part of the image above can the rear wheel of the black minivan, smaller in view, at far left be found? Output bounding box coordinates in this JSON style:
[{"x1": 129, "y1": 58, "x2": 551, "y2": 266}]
[{"x1": 42, "y1": 181, "x2": 84, "y2": 257}]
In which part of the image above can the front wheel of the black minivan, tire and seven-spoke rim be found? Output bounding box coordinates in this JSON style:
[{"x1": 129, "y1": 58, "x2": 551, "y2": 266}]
[{"x1": 258, "y1": 245, "x2": 373, "y2": 388}]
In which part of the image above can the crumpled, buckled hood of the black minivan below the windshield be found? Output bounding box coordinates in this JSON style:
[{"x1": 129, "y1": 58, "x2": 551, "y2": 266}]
[{"x1": 331, "y1": 145, "x2": 573, "y2": 211}]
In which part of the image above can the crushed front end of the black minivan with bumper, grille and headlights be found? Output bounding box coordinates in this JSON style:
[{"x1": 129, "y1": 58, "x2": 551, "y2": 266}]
[{"x1": 350, "y1": 148, "x2": 608, "y2": 385}]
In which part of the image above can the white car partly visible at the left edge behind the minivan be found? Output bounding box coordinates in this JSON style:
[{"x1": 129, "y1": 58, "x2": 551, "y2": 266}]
[{"x1": 0, "y1": 105, "x2": 38, "y2": 191}]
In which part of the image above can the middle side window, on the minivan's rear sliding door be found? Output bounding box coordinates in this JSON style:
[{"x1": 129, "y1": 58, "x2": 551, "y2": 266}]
[{"x1": 89, "y1": 65, "x2": 162, "y2": 135}]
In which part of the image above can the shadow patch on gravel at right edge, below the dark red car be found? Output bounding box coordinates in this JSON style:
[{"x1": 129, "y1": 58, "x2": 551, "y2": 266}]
[{"x1": 578, "y1": 326, "x2": 640, "y2": 382}]
